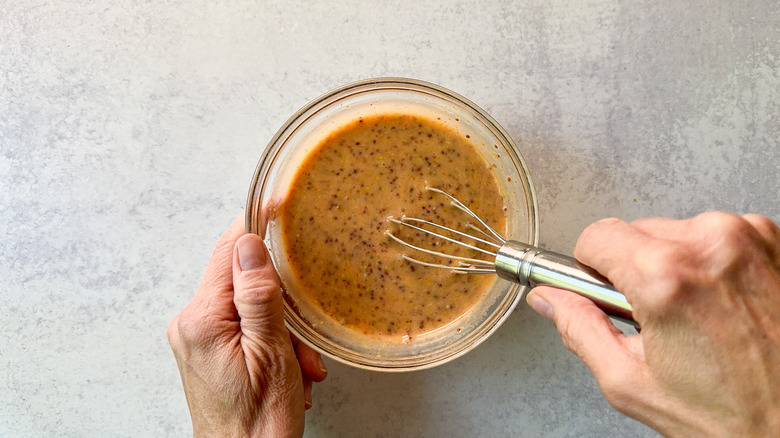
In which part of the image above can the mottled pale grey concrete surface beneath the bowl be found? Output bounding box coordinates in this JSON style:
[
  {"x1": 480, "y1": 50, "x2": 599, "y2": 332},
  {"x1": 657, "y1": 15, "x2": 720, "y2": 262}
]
[{"x1": 0, "y1": 0, "x2": 780, "y2": 437}]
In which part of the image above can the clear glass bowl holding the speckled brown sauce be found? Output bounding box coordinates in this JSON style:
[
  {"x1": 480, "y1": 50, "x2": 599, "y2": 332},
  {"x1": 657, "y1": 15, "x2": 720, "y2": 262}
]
[{"x1": 246, "y1": 78, "x2": 539, "y2": 371}]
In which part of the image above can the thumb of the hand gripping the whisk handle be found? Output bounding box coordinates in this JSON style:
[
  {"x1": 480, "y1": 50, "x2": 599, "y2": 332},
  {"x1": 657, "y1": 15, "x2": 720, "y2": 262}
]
[{"x1": 526, "y1": 286, "x2": 644, "y2": 385}]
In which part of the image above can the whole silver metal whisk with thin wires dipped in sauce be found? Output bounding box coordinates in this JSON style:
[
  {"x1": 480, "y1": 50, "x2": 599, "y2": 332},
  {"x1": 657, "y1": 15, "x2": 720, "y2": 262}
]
[{"x1": 386, "y1": 187, "x2": 639, "y2": 327}]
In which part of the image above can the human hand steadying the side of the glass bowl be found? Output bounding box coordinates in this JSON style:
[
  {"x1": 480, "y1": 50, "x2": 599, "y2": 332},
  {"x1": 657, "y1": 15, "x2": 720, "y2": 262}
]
[{"x1": 168, "y1": 214, "x2": 327, "y2": 437}]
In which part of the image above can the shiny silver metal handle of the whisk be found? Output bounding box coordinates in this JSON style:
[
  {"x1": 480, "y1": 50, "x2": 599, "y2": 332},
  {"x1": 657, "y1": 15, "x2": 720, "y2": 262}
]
[{"x1": 495, "y1": 240, "x2": 639, "y2": 327}]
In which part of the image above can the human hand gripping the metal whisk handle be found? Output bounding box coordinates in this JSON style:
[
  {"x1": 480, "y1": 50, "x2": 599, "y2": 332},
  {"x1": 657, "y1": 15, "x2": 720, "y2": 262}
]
[{"x1": 527, "y1": 212, "x2": 780, "y2": 437}]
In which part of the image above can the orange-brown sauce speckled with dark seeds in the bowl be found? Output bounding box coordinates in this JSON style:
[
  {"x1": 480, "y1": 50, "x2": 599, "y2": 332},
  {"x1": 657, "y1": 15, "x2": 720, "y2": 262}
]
[{"x1": 280, "y1": 114, "x2": 506, "y2": 340}]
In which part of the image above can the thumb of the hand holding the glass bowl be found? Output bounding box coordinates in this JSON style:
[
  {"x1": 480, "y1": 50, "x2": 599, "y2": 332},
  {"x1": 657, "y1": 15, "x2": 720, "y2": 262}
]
[{"x1": 233, "y1": 233, "x2": 287, "y2": 339}]
